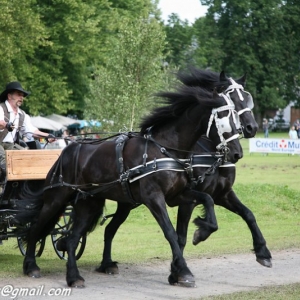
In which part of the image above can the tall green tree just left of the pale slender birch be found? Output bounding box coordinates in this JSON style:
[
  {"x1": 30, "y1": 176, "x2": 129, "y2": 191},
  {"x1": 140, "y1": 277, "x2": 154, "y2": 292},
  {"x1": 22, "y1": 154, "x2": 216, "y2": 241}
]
[{"x1": 30, "y1": 0, "x2": 114, "y2": 117}]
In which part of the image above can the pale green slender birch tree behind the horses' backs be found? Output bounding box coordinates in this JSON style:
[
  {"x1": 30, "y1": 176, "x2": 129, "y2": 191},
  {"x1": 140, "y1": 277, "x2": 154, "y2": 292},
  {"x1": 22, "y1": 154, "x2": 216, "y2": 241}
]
[{"x1": 85, "y1": 17, "x2": 165, "y2": 131}]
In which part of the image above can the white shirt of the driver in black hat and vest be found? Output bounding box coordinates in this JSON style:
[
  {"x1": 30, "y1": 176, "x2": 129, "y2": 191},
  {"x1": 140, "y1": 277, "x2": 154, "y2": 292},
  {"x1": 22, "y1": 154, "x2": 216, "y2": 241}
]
[{"x1": 0, "y1": 100, "x2": 38, "y2": 143}]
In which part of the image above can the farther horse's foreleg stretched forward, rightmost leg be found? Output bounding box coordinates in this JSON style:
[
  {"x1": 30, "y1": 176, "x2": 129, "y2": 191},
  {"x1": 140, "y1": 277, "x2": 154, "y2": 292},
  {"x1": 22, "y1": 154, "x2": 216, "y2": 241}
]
[{"x1": 215, "y1": 190, "x2": 272, "y2": 268}]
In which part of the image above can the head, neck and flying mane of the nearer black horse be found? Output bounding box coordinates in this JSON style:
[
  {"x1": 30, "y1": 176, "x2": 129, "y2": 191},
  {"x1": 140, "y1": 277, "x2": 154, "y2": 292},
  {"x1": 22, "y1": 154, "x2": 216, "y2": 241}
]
[{"x1": 141, "y1": 82, "x2": 243, "y2": 162}]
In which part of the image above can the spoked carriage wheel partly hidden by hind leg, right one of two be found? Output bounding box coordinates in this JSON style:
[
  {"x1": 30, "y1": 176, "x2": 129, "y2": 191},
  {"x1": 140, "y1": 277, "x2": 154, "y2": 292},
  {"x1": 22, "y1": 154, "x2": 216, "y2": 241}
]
[{"x1": 51, "y1": 206, "x2": 86, "y2": 260}]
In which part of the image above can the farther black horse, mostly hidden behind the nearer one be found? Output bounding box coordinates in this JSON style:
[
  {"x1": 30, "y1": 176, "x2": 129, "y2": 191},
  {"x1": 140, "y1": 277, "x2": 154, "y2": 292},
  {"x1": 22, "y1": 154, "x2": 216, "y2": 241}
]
[{"x1": 168, "y1": 68, "x2": 272, "y2": 267}]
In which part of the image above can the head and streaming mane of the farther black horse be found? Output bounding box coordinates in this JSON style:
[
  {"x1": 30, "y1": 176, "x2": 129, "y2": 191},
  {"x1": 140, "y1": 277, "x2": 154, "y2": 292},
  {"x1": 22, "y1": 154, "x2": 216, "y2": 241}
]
[{"x1": 178, "y1": 68, "x2": 258, "y2": 138}]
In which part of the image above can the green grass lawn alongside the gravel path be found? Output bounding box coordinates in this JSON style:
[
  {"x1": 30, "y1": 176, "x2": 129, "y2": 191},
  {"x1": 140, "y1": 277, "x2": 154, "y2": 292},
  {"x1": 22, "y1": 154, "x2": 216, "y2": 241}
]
[{"x1": 0, "y1": 133, "x2": 300, "y2": 300}]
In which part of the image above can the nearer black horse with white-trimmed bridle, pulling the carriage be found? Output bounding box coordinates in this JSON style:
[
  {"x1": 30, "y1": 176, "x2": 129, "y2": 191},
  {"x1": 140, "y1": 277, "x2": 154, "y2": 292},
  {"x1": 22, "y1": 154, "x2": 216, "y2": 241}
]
[{"x1": 23, "y1": 77, "x2": 242, "y2": 286}]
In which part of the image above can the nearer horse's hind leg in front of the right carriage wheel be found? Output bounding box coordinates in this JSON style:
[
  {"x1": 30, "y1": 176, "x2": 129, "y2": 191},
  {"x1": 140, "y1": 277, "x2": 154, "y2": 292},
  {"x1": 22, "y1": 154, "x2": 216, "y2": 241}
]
[{"x1": 61, "y1": 197, "x2": 105, "y2": 287}]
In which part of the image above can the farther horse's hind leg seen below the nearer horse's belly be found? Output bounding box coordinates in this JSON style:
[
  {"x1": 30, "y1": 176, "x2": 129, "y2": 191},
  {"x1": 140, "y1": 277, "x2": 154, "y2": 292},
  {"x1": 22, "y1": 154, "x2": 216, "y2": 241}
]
[{"x1": 96, "y1": 202, "x2": 132, "y2": 274}]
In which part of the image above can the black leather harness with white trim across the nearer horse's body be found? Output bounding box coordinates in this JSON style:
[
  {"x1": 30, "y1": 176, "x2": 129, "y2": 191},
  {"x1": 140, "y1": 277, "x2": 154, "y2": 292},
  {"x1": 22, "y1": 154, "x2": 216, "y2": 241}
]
[{"x1": 44, "y1": 132, "x2": 235, "y2": 206}]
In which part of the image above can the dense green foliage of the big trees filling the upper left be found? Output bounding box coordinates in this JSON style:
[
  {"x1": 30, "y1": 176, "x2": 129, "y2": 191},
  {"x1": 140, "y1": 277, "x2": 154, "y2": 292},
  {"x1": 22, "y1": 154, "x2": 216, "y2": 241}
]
[{"x1": 0, "y1": 0, "x2": 156, "y2": 117}]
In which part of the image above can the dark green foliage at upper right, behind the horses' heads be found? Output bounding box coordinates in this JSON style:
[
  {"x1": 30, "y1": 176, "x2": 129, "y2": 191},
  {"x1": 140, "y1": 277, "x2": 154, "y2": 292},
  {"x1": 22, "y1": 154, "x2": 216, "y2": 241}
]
[{"x1": 165, "y1": 0, "x2": 300, "y2": 115}]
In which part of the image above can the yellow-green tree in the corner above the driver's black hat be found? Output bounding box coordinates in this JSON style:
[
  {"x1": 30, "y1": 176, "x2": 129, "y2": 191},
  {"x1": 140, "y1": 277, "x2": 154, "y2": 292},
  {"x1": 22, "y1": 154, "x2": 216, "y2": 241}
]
[{"x1": 0, "y1": 0, "x2": 47, "y2": 98}]
